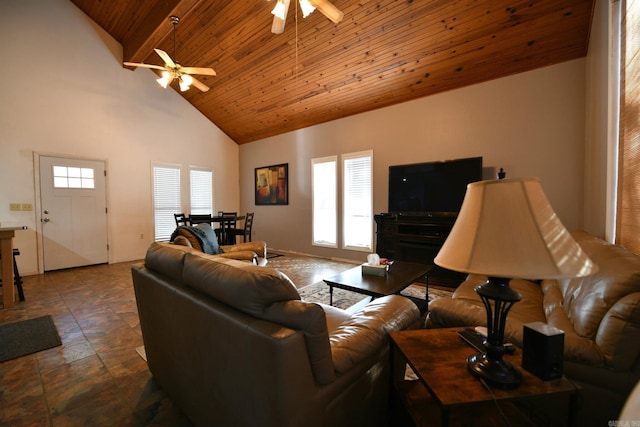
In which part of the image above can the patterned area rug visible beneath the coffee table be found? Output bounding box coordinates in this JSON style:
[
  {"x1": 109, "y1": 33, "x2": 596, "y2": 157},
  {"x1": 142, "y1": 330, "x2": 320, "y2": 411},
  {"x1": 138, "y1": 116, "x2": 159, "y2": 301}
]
[{"x1": 298, "y1": 282, "x2": 452, "y2": 310}]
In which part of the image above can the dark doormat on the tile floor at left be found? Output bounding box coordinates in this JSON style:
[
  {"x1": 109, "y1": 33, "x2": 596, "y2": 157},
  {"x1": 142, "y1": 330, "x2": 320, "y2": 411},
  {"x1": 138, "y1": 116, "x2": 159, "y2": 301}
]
[{"x1": 0, "y1": 316, "x2": 62, "y2": 362}]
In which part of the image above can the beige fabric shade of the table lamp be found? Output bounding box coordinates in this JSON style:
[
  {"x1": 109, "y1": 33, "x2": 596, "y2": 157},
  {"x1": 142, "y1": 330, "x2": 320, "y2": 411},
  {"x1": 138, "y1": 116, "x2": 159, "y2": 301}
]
[{"x1": 434, "y1": 178, "x2": 598, "y2": 279}]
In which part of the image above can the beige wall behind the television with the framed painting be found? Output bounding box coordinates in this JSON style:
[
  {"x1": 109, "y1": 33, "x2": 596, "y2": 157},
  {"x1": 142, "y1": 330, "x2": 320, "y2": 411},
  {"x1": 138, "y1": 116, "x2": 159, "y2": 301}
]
[{"x1": 240, "y1": 59, "x2": 585, "y2": 260}]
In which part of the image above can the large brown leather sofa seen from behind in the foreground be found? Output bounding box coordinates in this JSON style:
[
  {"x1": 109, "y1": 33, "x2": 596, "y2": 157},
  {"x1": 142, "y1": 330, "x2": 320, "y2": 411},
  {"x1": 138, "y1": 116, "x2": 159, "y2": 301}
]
[{"x1": 132, "y1": 243, "x2": 420, "y2": 427}]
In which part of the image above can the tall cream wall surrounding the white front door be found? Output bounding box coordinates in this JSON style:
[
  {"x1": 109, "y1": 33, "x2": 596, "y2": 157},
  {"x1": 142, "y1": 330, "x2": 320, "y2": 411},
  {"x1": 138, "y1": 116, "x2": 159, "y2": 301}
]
[{"x1": 0, "y1": 0, "x2": 239, "y2": 274}]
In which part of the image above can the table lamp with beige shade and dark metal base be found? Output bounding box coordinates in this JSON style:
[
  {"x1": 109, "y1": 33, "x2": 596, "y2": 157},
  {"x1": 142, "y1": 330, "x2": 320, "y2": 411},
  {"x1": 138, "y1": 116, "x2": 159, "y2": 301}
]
[{"x1": 434, "y1": 178, "x2": 597, "y2": 389}]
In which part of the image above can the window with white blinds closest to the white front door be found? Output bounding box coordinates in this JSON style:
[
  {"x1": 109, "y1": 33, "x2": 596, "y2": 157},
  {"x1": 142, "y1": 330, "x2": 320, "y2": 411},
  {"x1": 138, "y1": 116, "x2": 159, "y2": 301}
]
[{"x1": 153, "y1": 165, "x2": 181, "y2": 241}]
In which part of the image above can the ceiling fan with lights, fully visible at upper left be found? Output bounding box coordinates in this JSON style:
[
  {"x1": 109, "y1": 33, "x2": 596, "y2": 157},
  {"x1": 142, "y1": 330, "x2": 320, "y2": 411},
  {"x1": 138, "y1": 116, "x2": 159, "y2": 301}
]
[{"x1": 124, "y1": 16, "x2": 216, "y2": 92}]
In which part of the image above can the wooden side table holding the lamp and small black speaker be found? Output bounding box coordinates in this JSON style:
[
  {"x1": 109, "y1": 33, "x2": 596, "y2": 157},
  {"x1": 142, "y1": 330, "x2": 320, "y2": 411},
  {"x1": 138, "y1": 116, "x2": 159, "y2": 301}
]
[{"x1": 390, "y1": 328, "x2": 578, "y2": 426}]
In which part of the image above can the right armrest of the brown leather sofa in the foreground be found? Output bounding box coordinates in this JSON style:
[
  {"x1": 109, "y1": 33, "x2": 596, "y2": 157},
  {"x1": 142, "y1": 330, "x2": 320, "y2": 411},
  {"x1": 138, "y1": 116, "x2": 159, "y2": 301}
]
[{"x1": 329, "y1": 295, "x2": 420, "y2": 374}]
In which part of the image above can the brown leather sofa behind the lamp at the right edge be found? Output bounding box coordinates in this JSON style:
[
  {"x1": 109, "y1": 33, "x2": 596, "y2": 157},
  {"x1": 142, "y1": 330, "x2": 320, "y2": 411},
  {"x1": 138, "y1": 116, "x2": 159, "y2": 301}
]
[{"x1": 426, "y1": 231, "x2": 640, "y2": 426}]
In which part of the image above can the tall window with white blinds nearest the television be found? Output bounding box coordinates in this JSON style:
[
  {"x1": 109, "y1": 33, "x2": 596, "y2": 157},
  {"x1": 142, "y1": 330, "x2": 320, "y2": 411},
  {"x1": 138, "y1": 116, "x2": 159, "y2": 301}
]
[{"x1": 342, "y1": 150, "x2": 373, "y2": 252}]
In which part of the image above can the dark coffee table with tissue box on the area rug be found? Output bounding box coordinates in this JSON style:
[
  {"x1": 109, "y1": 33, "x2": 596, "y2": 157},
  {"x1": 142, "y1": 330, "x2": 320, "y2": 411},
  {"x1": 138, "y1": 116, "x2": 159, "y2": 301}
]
[{"x1": 323, "y1": 261, "x2": 433, "y2": 305}]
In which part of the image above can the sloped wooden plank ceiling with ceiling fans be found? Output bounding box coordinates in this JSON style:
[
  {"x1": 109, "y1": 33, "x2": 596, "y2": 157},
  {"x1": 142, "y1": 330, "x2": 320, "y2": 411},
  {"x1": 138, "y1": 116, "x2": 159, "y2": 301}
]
[{"x1": 71, "y1": 0, "x2": 594, "y2": 144}]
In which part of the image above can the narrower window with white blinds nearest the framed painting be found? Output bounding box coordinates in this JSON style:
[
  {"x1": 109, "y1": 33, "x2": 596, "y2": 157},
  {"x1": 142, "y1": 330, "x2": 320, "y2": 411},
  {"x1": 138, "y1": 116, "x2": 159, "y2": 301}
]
[{"x1": 311, "y1": 156, "x2": 338, "y2": 248}]
